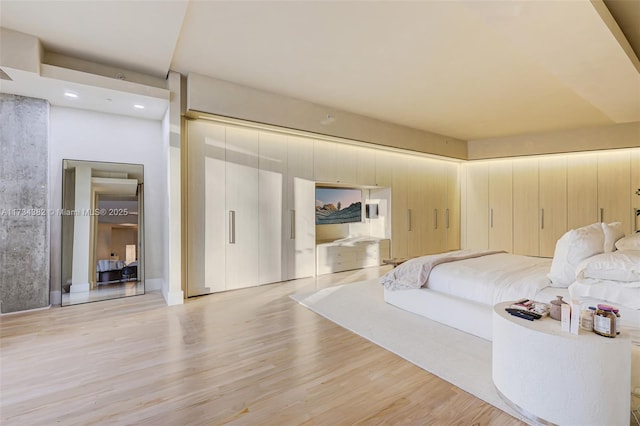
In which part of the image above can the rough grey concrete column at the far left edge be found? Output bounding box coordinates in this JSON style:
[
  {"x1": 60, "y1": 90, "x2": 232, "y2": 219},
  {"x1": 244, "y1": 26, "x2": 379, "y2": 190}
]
[{"x1": 0, "y1": 94, "x2": 50, "y2": 313}]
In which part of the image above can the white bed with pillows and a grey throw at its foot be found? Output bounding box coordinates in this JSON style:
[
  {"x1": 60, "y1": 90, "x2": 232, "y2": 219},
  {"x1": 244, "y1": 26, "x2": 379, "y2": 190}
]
[{"x1": 380, "y1": 223, "x2": 640, "y2": 345}]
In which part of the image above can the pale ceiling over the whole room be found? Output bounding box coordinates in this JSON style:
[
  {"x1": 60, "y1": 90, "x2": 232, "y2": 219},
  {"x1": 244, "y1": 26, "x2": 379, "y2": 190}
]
[{"x1": 0, "y1": 0, "x2": 640, "y2": 140}]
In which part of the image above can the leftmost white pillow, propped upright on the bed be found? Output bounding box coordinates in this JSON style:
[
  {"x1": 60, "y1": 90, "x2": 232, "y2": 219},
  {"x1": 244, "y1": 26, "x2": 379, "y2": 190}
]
[{"x1": 547, "y1": 223, "x2": 604, "y2": 287}]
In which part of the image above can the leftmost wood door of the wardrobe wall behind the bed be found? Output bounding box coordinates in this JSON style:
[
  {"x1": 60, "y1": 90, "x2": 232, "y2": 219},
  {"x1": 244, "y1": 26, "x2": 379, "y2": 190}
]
[{"x1": 465, "y1": 163, "x2": 489, "y2": 250}]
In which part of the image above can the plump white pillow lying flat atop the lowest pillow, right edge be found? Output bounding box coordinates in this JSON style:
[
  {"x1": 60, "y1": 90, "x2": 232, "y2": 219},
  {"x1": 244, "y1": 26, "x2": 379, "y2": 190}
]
[{"x1": 576, "y1": 250, "x2": 640, "y2": 282}]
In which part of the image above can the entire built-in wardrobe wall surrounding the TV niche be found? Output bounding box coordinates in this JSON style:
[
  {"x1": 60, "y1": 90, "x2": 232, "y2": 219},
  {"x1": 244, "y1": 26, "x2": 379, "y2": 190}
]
[{"x1": 185, "y1": 119, "x2": 460, "y2": 297}]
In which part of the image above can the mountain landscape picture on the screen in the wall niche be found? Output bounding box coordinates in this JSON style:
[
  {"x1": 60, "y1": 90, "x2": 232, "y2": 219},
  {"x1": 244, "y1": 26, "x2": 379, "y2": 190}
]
[{"x1": 316, "y1": 187, "x2": 362, "y2": 225}]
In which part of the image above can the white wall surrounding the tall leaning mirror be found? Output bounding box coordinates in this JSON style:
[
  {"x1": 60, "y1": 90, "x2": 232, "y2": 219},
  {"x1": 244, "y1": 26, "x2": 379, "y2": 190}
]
[{"x1": 49, "y1": 106, "x2": 168, "y2": 305}]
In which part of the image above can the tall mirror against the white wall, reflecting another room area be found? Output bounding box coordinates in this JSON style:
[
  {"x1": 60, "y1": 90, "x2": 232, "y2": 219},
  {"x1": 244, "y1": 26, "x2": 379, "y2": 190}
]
[{"x1": 60, "y1": 160, "x2": 144, "y2": 306}]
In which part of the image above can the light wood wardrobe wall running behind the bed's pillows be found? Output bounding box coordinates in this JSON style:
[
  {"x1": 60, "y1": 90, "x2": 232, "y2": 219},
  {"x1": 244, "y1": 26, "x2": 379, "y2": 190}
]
[{"x1": 463, "y1": 149, "x2": 640, "y2": 257}]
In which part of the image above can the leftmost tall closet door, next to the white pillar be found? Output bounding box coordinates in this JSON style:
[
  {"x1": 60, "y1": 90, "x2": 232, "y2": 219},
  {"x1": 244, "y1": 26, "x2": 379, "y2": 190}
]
[{"x1": 186, "y1": 121, "x2": 226, "y2": 297}]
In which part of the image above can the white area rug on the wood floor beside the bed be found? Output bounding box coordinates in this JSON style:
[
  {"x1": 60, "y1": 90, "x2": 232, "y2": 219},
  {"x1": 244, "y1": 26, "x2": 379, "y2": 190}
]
[{"x1": 291, "y1": 278, "x2": 529, "y2": 423}]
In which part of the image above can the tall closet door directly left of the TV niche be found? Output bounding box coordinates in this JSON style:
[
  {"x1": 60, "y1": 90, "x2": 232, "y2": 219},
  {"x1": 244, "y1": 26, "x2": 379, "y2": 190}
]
[{"x1": 285, "y1": 136, "x2": 316, "y2": 279}]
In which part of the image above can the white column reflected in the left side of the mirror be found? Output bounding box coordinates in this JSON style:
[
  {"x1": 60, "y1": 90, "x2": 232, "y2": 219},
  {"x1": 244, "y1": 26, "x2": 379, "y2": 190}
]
[{"x1": 71, "y1": 166, "x2": 91, "y2": 293}]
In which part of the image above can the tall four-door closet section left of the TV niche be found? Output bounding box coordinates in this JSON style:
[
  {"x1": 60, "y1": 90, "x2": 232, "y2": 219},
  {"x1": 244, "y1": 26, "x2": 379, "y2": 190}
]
[{"x1": 185, "y1": 120, "x2": 315, "y2": 297}]
